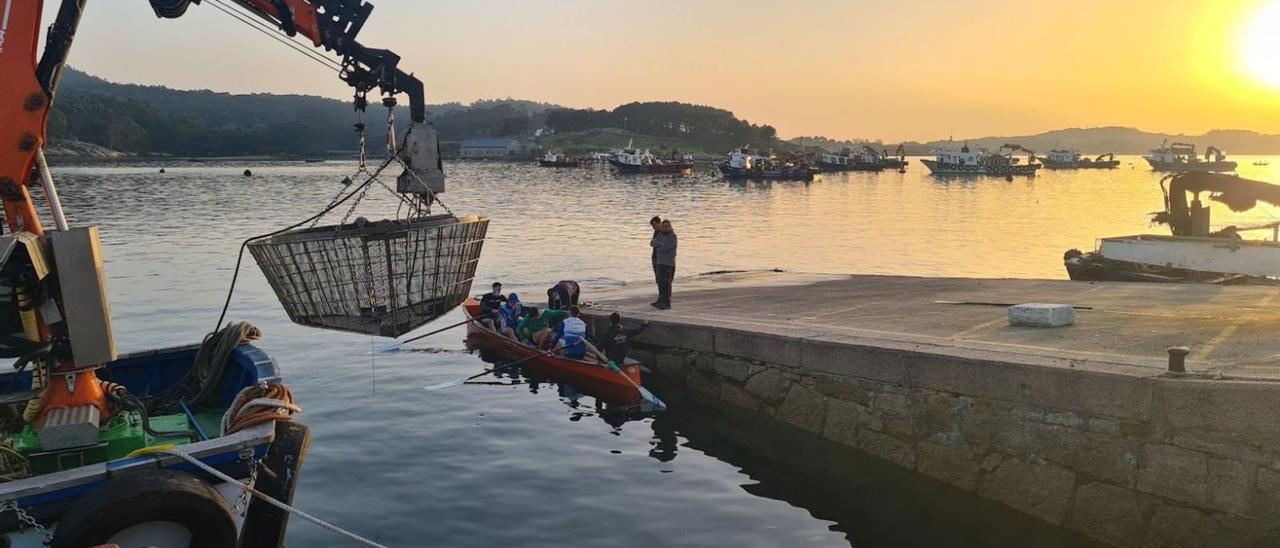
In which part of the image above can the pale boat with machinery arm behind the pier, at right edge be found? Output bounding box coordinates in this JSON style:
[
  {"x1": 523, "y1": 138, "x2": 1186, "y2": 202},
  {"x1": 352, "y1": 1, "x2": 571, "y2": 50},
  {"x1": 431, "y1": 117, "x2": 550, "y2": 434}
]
[{"x1": 1062, "y1": 172, "x2": 1280, "y2": 284}]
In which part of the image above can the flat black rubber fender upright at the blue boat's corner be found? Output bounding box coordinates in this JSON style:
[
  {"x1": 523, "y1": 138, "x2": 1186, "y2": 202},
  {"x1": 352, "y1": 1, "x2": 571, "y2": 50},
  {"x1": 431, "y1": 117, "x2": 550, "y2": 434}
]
[{"x1": 241, "y1": 420, "x2": 311, "y2": 548}]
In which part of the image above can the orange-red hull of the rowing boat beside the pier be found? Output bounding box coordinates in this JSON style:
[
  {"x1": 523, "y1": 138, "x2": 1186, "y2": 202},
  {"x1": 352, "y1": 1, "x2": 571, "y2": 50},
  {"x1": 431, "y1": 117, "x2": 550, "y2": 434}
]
[{"x1": 463, "y1": 298, "x2": 641, "y2": 403}]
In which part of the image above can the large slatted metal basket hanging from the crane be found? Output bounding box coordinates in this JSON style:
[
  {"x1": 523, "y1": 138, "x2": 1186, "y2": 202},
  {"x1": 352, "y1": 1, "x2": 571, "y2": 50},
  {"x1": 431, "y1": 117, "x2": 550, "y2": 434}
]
[{"x1": 248, "y1": 215, "x2": 489, "y2": 337}]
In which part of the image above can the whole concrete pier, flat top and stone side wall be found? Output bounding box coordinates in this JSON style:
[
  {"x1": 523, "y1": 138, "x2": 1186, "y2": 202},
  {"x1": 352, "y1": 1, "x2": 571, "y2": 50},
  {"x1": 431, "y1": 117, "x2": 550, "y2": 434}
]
[{"x1": 585, "y1": 273, "x2": 1280, "y2": 547}]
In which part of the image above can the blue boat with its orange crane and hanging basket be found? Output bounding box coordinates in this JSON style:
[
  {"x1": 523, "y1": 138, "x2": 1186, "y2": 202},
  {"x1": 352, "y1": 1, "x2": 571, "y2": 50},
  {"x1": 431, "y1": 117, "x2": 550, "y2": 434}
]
[{"x1": 0, "y1": 0, "x2": 488, "y2": 548}]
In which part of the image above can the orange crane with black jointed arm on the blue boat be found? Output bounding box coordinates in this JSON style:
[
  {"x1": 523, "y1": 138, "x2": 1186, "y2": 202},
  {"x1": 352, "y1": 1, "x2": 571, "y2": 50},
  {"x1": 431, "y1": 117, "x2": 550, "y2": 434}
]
[{"x1": 0, "y1": 0, "x2": 444, "y2": 432}]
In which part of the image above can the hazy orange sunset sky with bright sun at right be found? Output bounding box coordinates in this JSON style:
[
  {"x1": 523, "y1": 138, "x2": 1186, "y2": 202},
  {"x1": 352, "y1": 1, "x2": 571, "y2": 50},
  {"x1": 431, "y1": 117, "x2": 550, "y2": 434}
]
[{"x1": 37, "y1": 0, "x2": 1280, "y2": 142}]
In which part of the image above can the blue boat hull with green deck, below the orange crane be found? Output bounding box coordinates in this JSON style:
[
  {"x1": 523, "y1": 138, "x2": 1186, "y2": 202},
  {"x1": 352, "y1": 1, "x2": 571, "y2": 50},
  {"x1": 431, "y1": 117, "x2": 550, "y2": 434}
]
[{"x1": 0, "y1": 344, "x2": 310, "y2": 547}]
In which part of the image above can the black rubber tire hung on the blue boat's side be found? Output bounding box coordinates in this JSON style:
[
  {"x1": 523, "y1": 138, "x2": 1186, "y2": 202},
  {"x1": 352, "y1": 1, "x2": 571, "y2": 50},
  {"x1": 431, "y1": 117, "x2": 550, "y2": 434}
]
[{"x1": 51, "y1": 470, "x2": 236, "y2": 548}]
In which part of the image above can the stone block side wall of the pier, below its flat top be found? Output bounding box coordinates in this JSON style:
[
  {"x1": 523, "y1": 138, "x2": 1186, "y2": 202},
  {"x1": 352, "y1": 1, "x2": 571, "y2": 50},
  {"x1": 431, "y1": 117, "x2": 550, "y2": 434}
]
[{"x1": 588, "y1": 311, "x2": 1280, "y2": 547}]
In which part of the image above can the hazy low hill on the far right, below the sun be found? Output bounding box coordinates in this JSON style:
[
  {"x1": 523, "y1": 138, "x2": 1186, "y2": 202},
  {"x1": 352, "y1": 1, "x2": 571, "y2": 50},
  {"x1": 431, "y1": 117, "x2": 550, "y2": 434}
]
[{"x1": 905, "y1": 127, "x2": 1280, "y2": 155}]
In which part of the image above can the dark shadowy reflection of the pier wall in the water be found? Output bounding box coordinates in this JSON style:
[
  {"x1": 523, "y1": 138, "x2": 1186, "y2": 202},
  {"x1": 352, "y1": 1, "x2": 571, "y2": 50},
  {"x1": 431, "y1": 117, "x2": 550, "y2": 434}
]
[{"x1": 649, "y1": 387, "x2": 1102, "y2": 548}]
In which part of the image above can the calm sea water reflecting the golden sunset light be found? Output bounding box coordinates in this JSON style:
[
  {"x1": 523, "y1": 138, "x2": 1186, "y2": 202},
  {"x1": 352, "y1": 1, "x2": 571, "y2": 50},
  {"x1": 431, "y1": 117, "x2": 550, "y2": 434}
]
[{"x1": 40, "y1": 157, "x2": 1280, "y2": 547}]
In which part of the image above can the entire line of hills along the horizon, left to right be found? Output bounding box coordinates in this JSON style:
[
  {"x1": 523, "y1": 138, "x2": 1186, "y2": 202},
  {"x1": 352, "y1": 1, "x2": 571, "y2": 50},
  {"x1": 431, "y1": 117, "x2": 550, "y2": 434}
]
[{"x1": 50, "y1": 69, "x2": 1280, "y2": 156}]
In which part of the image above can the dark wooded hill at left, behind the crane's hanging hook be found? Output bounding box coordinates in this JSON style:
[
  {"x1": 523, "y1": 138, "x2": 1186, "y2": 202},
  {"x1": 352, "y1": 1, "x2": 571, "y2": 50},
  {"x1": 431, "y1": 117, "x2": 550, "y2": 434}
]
[{"x1": 49, "y1": 69, "x2": 558, "y2": 156}]
